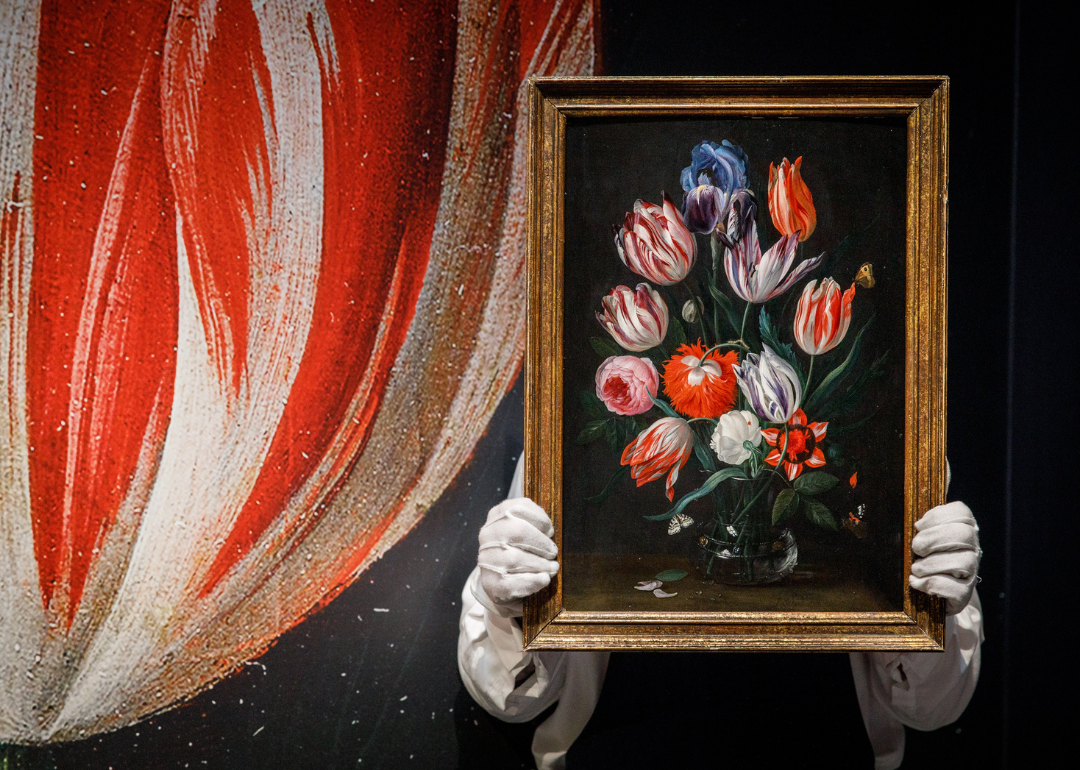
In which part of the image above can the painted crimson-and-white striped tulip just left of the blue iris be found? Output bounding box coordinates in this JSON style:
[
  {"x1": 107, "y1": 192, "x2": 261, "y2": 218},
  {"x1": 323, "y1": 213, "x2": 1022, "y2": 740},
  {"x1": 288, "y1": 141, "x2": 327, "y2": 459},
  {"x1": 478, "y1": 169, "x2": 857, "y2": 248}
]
[{"x1": 615, "y1": 193, "x2": 698, "y2": 286}]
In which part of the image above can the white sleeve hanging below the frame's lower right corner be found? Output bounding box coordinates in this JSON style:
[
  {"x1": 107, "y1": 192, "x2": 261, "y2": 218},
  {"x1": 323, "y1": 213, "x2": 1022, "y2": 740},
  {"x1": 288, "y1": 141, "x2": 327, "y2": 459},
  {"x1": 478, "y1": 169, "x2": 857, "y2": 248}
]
[{"x1": 851, "y1": 592, "x2": 983, "y2": 770}]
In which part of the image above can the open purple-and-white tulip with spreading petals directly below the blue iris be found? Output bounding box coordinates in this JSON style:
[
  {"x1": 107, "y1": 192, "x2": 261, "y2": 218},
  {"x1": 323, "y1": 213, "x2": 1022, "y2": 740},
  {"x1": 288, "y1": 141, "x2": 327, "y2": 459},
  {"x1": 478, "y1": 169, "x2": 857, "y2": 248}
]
[{"x1": 724, "y1": 219, "x2": 825, "y2": 305}]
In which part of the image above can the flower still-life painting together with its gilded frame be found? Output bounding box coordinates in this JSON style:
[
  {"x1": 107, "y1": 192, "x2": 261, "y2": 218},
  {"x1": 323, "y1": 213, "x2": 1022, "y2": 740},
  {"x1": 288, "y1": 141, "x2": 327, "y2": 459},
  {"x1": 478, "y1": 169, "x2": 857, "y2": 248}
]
[{"x1": 523, "y1": 77, "x2": 948, "y2": 650}]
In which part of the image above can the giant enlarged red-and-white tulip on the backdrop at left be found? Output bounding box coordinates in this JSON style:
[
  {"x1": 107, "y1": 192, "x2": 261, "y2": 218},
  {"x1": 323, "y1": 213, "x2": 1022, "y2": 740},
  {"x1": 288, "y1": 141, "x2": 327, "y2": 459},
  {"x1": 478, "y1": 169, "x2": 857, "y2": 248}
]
[{"x1": 0, "y1": 0, "x2": 593, "y2": 743}]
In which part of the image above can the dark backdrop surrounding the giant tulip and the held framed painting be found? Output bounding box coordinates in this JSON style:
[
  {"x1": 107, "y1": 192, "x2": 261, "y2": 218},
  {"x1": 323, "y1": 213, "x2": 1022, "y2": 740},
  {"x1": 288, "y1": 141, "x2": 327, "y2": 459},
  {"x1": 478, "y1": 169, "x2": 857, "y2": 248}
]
[{"x1": 6, "y1": 1, "x2": 1080, "y2": 770}]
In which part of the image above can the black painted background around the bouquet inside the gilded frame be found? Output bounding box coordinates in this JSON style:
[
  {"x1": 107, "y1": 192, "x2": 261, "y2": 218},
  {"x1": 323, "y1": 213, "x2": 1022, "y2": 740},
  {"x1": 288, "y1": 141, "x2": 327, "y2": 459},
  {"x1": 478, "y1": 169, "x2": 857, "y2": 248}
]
[{"x1": 563, "y1": 119, "x2": 907, "y2": 610}]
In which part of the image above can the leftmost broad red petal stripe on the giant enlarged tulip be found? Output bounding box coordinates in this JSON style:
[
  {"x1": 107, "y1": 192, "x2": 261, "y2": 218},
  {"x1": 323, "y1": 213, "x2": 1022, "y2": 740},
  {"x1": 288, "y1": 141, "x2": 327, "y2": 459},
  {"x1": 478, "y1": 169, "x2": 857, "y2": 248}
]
[{"x1": 26, "y1": 0, "x2": 177, "y2": 623}]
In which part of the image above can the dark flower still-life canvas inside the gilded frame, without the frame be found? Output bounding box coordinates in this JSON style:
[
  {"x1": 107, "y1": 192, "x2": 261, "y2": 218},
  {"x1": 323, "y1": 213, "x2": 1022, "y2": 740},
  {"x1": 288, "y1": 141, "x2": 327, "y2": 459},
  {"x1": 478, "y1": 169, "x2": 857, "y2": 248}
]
[{"x1": 563, "y1": 119, "x2": 906, "y2": 611}]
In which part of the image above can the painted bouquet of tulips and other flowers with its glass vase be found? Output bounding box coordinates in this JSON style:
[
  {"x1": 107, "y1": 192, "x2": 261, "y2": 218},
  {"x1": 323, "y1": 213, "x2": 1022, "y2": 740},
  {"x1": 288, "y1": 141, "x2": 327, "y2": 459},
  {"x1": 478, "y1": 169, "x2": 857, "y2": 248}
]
[{"x1": 578, "y1": 140, "x2": 886, "y2": 584}]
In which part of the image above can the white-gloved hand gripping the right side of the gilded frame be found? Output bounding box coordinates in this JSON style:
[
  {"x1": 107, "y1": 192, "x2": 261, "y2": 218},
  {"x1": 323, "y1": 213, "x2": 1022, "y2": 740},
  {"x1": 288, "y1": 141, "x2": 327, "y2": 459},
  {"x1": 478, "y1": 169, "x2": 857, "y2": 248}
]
[{"x1": 907, "y1": 461, "x2": 983, "y2": 614}]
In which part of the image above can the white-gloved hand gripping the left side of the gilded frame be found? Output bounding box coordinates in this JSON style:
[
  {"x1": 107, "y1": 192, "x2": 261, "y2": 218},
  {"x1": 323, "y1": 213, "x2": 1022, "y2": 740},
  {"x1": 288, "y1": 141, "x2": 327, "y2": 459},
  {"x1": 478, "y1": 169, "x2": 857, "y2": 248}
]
[{"x1": 476, "y1": 497, "x2": 558, "y2": 616}]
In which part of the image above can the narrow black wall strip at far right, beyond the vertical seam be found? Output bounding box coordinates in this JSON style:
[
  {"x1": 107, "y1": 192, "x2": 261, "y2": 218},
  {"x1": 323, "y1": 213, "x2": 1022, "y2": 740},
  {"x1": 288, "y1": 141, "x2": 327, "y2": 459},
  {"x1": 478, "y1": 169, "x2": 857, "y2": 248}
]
[{"x1": 1006, "y1": 2, "x2": 1080, "y2": 767}]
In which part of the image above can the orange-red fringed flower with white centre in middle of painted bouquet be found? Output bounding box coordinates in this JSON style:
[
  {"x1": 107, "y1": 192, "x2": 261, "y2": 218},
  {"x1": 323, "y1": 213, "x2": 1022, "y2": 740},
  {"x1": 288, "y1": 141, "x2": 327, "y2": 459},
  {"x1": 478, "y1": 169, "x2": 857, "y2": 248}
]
[{"x1": 664, "y1": 341, "x2": 739, "y2": 417}]
